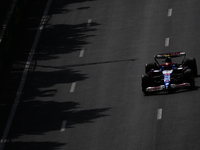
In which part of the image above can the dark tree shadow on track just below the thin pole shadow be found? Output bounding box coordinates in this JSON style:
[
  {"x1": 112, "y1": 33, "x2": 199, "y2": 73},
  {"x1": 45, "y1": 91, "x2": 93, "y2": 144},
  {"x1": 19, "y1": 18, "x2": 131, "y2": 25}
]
[{"x1": 23, "y1": 69, "x2": 88, "y2": 100}]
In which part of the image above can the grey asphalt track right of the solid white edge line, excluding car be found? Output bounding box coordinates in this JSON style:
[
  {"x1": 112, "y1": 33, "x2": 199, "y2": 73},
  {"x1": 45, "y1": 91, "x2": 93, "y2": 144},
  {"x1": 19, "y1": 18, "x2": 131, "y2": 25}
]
[{"x1": 1, "y1": 0, "x2": 200, "y2": 150}]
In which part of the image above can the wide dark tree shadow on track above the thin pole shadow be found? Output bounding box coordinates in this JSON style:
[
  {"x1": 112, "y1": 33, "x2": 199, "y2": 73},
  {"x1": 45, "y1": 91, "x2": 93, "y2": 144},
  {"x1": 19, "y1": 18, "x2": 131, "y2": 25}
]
[{"x1": 38, "y1": 22, "x2": 100, "y2": 60}]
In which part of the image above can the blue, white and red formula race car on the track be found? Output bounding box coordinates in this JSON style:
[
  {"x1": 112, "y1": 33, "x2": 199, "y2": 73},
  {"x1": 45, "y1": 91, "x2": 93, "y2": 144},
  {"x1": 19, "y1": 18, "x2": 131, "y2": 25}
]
[{"x1": 142, "y1": 52, "x2": 197, "y2": 94}]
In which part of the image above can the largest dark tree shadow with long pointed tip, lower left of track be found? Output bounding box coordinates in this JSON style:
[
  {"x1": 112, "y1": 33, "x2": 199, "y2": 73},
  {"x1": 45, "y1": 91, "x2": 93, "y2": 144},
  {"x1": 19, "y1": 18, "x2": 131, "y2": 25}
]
[{"x1": 9, "y1": 100, "x2": 111, "y2": 139}]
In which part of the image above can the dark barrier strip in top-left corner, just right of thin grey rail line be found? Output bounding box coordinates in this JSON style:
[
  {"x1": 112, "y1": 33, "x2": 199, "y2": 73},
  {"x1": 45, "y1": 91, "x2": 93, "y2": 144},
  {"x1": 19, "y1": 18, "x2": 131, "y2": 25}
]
[{"x1": 0, "y1": 0, "x2": 28, "y2": 76}]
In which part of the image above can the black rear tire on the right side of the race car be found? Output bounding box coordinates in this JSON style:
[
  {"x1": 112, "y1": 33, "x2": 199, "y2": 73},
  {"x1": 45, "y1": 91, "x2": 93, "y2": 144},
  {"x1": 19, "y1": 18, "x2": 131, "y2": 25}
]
[{"x1": 183, "y1": 58, "x2": 197, "y2": 77}]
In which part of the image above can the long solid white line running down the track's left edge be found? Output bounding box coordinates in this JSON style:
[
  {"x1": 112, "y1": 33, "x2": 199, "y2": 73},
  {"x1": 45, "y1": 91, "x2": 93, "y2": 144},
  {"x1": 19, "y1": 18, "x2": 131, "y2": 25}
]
[{"x1": 0, "y1": 0, "x2": 52, "y2": 150}]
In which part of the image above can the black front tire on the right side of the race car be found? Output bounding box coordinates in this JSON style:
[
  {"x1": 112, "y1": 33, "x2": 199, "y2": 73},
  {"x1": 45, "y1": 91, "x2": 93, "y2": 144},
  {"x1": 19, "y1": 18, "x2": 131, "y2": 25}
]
[{"x1": 183, "y1": 69, "x2": 195, "y2": 87}]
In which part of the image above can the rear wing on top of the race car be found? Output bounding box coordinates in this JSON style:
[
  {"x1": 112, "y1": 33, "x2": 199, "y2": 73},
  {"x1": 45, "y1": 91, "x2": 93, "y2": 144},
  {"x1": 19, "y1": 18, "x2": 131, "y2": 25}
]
[{"x1": 154, "y1": 52, "x2": 186, "y2": 64}]
